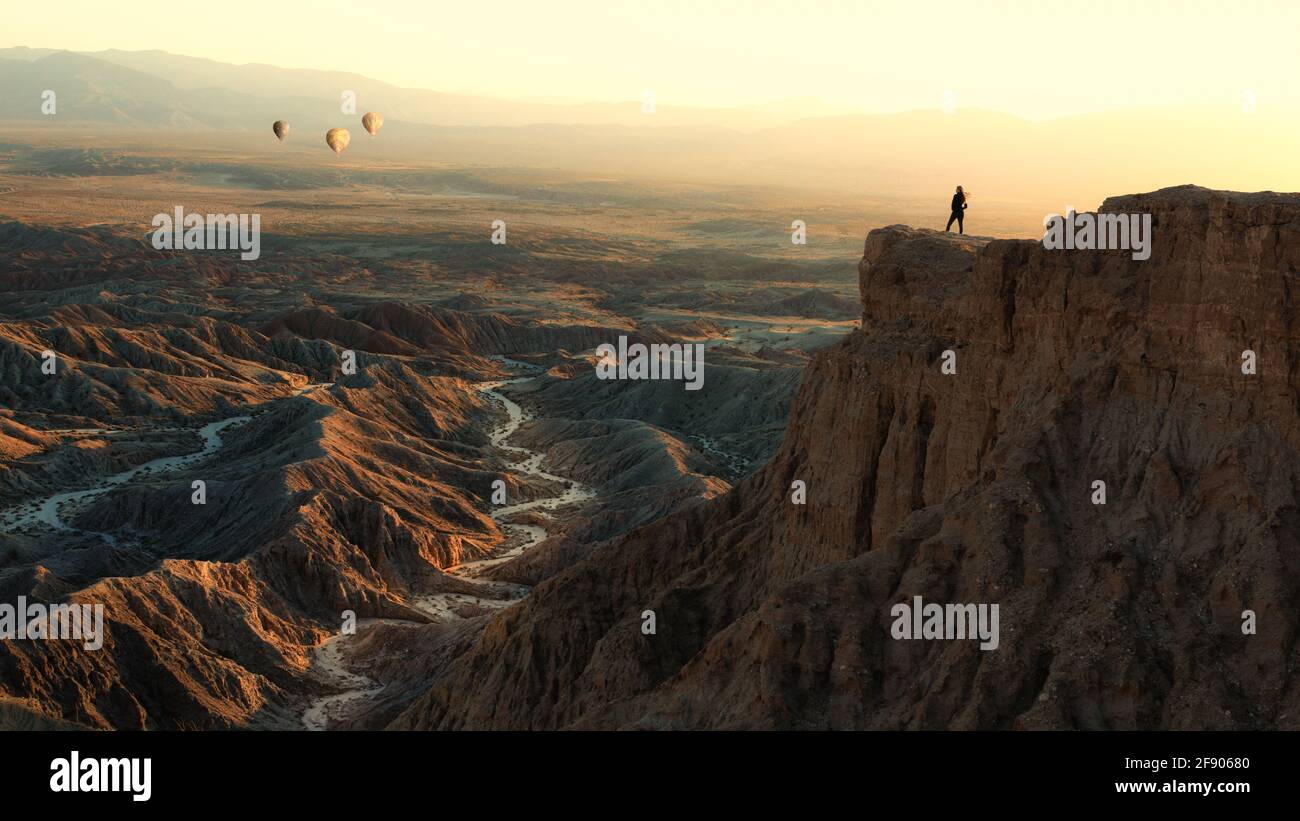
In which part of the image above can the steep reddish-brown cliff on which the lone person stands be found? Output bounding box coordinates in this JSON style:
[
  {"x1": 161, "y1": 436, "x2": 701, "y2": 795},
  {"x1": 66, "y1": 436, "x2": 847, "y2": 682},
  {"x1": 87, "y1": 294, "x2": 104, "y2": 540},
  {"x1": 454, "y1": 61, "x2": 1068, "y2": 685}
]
[{"x1": 393, "y1": 187, "x2": 1300, "y2": 729}]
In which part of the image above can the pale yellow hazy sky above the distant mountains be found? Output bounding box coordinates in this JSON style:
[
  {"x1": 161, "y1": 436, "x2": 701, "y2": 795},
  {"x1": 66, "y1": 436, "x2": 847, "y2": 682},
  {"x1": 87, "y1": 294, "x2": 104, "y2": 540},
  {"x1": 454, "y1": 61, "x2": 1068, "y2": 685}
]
[{"x1": 10, "y1": 0, "x2": 1300, "y2": 118}]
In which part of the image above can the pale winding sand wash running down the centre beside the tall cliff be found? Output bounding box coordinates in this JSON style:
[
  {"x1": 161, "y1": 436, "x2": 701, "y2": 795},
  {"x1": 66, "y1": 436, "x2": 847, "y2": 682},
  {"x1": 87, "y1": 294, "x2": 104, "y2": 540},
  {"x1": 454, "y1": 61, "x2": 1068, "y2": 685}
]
[{"x1": 303, "y1": 357, "x2": 595, "y2": 730}]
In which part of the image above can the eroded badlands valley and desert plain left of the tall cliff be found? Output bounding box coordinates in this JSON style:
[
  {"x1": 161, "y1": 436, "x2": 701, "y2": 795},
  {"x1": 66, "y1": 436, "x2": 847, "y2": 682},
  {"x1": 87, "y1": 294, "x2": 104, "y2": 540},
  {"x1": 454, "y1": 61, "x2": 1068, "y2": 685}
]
[{"x1": 0, "y1": 130, "x2": 861, "y2": 729}]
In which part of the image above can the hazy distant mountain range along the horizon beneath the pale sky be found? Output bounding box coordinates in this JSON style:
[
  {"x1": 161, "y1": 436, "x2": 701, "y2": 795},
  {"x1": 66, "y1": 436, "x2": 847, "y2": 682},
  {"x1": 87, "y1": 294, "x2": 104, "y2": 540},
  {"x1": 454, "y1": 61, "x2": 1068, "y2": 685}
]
[{"x1": 0, "y1": 48, "x2": 1300, "y2": 223}]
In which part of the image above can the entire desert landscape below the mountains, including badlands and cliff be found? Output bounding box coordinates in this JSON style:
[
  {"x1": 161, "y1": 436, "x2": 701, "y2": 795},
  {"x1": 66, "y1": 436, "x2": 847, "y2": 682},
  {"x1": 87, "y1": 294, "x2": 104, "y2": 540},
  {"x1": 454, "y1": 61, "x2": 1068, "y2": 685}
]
[{"x1": 0, "y1": 129, "x2": 1300, "y2": 729}]
